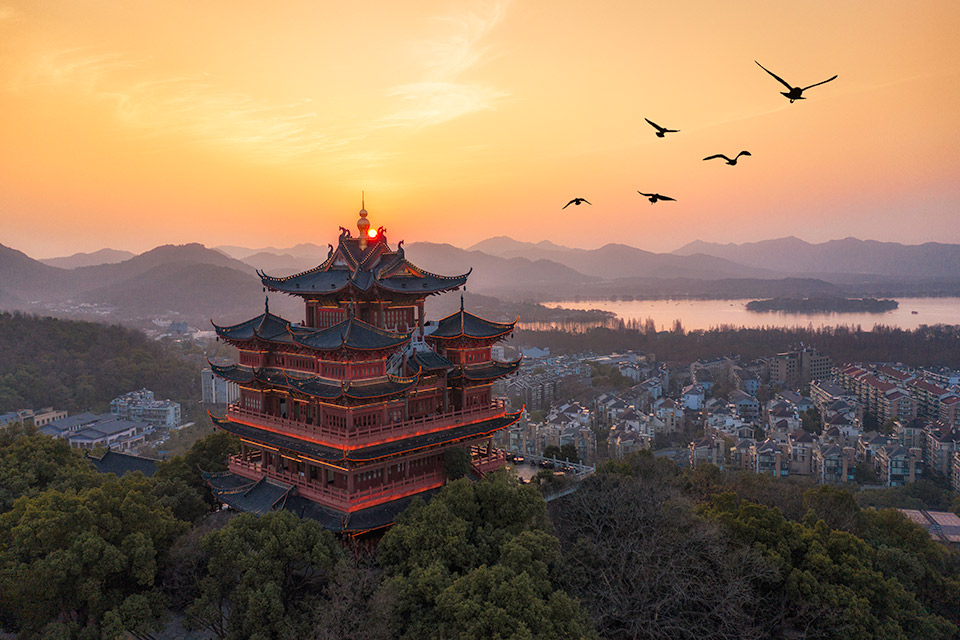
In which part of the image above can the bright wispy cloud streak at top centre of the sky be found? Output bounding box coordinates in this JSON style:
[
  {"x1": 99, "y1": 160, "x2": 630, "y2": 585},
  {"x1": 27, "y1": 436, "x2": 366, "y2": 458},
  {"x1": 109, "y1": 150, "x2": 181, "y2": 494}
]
[{"x1": 379, "y1": 2, "x2": 507, "y2": 127}]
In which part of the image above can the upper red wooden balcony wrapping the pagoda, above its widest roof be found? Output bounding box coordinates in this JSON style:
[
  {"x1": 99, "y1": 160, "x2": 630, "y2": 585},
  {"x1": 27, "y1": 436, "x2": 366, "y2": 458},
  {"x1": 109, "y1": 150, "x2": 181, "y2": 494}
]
[{"x1": 227, "y1": 399, "x2": 506, "y2": 449}]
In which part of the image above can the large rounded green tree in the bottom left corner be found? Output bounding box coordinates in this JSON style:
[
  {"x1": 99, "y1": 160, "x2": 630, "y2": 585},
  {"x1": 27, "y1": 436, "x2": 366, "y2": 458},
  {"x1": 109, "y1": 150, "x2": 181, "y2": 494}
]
[{"x1": 0, "y1": 473, "x2": 186, "y2": 637}]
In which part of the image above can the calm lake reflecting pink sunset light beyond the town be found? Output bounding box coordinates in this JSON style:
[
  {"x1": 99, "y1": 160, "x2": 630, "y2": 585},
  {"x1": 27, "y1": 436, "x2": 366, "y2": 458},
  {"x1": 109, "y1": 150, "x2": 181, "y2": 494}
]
[{"x1": 540, "y1": 298, "x2": 960, "y2": 331}]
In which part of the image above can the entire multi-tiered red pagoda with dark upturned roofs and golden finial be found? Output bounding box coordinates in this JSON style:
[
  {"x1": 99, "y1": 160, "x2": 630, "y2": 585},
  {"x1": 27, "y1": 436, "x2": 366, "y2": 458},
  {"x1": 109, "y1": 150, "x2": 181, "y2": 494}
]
[{"x1": 205, "y1": 201, "x2": 520, "y2": 536}]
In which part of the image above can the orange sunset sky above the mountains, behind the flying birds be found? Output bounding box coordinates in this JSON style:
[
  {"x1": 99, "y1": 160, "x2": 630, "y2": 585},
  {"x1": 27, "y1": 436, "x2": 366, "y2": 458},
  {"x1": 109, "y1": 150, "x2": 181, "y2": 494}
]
[{"x1": 0, "y1": 0, "x2": 960, "y2": 257}]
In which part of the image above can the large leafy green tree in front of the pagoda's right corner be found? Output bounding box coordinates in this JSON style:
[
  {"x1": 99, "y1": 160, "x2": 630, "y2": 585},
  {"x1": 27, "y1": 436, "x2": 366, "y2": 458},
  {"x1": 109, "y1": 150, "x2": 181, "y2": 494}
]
[{"x1": 378, "y1": 472, "x2": 593, "y2": 638}]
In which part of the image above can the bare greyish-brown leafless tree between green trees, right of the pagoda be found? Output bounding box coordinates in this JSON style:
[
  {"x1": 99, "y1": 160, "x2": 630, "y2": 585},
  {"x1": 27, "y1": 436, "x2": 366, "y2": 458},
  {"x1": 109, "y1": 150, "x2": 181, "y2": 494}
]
[{"x1": 551, "y1": 456, "x2": 767, "y2": 639}]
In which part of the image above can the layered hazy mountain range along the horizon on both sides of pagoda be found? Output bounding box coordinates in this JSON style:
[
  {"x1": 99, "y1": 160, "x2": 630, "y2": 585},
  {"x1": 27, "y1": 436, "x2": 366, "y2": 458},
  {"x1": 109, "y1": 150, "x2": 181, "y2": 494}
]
[{"x1": 0, "y1": 236, "x2": 960, "y2": 326}]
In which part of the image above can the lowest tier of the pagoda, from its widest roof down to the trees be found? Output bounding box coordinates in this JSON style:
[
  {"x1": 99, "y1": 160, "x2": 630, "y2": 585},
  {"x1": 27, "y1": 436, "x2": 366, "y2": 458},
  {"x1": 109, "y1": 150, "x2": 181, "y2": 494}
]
[{"x1": 207, "y1": 405, "x2": 520, "y2": 532}]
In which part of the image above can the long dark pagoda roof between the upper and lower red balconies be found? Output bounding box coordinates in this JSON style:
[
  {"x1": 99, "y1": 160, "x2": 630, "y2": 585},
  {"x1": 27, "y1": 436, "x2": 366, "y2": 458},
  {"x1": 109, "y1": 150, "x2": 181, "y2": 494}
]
[{"x1": 211, "y1": 412, "x2": 520, "y2": 462}]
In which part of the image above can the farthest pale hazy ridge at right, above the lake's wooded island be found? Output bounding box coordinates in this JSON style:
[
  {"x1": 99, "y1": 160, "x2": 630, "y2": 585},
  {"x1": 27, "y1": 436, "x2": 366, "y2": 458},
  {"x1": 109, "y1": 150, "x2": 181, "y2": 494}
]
[{"x1": 673, "y1": 236, "x2": 960, "y2": 279}]
